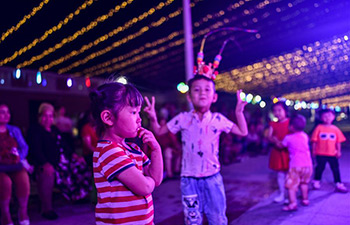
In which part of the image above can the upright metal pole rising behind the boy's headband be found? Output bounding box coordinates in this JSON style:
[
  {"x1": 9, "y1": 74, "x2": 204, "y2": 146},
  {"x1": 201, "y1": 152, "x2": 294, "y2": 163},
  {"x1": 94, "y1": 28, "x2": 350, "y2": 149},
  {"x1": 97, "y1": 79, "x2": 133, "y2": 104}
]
[{"x1": 182, "y1": 0, "x2": 194, "y2": 80}]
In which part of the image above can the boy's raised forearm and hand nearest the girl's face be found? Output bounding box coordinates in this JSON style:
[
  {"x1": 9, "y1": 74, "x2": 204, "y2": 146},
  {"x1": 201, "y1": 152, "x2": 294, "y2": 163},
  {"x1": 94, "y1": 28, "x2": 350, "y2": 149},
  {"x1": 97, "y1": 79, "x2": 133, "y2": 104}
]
[{"x1": 143, "y1": 96, "x2": 169, "y2": 136}]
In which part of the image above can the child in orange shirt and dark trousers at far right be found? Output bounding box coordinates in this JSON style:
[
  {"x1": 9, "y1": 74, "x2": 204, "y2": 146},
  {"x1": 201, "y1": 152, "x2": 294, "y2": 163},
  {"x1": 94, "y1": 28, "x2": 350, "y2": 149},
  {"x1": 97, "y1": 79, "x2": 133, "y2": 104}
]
[{"x1": 311, "y1": 109, "x2": 348, "y2": 193}]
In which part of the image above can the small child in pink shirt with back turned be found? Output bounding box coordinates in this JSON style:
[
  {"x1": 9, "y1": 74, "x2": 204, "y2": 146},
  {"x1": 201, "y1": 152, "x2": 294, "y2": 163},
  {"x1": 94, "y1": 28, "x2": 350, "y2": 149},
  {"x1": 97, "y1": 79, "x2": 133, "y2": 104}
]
[{"x1": 281, "y1": 115, "x2": 312, "y2": 211}]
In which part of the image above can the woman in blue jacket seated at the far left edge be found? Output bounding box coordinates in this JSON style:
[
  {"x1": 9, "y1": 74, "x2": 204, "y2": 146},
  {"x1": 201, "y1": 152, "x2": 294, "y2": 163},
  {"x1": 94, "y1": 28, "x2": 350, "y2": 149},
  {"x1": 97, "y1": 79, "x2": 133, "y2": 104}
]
[{"x1": 0, "y1": 103, "x2": 30, "y2": 225}]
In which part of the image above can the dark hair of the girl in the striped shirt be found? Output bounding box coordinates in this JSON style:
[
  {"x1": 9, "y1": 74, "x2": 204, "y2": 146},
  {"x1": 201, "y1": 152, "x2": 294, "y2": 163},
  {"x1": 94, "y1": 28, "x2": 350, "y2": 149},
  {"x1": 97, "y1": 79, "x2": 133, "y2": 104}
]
[{"x1": 89, "y1": 82, "x2": 143, "y2": 136}]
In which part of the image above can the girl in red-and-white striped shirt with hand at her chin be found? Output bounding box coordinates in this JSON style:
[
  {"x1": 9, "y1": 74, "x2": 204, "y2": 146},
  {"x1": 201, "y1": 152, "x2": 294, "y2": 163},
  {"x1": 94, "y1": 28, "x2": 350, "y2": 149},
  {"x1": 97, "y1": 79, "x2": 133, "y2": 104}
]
[{"x1": 90, "y1": 83, "x2": 163, "y2": 225}]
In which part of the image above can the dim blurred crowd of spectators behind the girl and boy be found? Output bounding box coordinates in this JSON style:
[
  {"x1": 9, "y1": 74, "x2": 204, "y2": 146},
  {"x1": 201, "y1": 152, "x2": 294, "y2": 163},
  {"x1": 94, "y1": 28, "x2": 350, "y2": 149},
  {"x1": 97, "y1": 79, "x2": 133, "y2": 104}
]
[{"x1": 0, "y1": 92, "x2": 350, "y2": 225}]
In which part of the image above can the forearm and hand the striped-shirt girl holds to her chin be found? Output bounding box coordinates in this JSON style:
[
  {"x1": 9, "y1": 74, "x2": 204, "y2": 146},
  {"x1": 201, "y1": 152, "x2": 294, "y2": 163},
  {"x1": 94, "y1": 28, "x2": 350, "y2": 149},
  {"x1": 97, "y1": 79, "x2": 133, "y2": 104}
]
[{"x1": 139, "y1": 128, "x2": 163, "y2": 186}]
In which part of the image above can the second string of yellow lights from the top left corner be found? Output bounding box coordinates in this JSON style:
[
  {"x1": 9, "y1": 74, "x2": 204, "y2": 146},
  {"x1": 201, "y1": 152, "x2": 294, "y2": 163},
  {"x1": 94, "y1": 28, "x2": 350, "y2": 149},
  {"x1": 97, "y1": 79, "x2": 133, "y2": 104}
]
[{"x1": 0, "y1": 0, "x2": 94, "y2": 66}]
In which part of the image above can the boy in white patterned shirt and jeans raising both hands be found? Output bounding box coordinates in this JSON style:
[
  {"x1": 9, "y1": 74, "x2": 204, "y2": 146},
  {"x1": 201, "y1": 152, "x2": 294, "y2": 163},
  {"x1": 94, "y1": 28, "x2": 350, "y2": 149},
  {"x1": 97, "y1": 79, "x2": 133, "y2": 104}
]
[{"x1": 144, "y1": 75, "x2": 248, "y2": 225}]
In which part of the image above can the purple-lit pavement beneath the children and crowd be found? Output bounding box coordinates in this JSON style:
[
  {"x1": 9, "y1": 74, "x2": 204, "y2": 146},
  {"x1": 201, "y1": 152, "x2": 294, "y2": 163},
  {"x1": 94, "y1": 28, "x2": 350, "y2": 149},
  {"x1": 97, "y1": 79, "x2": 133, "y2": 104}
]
[{"x1": 21, "y1": 148, "x2": 350, "y2": 225}]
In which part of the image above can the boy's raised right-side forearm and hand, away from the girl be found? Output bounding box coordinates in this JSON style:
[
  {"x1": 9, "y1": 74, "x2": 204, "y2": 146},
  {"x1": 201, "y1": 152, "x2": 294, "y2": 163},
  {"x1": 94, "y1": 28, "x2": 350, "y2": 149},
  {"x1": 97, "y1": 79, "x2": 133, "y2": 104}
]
[{"x1": 231, "y1": 90, "x2": 248, "y2": 136}]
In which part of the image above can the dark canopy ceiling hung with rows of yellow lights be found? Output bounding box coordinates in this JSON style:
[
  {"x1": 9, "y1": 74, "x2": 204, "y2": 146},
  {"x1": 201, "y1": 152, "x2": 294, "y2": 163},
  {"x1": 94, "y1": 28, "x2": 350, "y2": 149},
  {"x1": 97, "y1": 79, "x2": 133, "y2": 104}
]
[{"x1": 0, "y1": 0, "x2": 350, "y2": 95}]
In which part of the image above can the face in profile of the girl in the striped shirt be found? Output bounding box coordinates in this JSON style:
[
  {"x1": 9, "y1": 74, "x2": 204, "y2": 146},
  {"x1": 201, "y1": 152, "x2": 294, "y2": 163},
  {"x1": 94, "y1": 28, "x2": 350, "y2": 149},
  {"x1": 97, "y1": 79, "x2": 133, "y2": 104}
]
[{"x1": 113, "y1": 106, "x2": 142, "y2": 138}]
